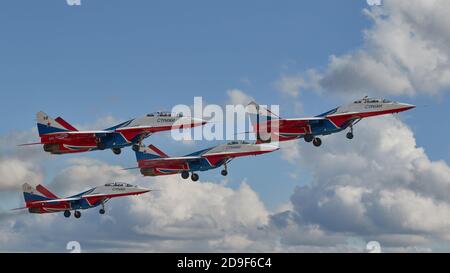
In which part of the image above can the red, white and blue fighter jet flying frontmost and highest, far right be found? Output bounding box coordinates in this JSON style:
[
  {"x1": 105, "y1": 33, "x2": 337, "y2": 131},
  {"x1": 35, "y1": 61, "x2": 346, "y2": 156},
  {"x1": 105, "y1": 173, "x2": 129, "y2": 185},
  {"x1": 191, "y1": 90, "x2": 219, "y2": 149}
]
[{"x1": 249, "y1": 96, "x2": 415, "y2": 147}]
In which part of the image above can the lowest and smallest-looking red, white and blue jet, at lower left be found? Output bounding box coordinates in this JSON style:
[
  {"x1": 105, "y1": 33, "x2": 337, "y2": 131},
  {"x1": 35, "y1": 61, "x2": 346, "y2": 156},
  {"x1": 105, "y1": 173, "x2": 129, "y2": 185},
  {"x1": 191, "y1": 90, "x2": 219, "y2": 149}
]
[{"x1": 15, "y1": 183, "x2": 151, "y2": 218}]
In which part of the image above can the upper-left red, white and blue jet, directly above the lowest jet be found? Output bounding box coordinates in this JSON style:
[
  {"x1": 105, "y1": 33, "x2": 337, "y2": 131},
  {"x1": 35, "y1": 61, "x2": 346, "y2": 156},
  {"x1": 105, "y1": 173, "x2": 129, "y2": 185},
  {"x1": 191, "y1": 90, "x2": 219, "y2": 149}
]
[{"x1": 19, "y1": 112, "x2": 206, "y2": 155}]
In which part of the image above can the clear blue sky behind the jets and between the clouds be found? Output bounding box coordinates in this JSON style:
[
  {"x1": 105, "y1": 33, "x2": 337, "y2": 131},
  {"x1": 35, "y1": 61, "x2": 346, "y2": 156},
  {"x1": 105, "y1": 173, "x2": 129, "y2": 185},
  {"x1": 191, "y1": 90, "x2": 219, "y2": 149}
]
[{"x1": 0, "y1": 0, "x2": 450, "y2": 252}]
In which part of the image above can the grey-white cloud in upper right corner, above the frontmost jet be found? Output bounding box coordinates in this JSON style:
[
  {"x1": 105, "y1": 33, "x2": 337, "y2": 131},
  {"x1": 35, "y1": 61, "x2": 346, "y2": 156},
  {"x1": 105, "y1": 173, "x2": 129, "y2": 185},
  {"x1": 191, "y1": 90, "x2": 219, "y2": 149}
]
[{"x1": 278, "y1": 0, "x2": 450, "y2": 96}]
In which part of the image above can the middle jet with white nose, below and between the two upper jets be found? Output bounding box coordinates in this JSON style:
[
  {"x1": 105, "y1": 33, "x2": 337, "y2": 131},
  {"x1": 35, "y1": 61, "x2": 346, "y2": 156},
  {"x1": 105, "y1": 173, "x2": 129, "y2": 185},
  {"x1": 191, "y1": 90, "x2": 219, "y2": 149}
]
[{"x1": 132, "y1": 141, "x2": 279, "y2": 181}]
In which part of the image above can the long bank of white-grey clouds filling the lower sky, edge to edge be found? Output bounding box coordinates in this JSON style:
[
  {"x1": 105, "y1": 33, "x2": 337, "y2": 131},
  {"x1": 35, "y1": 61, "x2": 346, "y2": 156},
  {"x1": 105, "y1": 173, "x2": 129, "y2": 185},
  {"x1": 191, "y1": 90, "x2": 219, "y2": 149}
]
[{"x1": 0, "y1": 112, "x2": 450, "y2": 252}]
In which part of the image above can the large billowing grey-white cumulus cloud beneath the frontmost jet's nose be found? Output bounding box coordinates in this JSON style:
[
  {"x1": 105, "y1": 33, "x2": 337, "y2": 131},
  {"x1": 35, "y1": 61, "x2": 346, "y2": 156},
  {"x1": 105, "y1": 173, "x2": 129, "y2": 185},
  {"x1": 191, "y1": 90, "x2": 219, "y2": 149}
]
[{"x1": 272, "y1": 117, "x2": 450, "y2": 247}]
